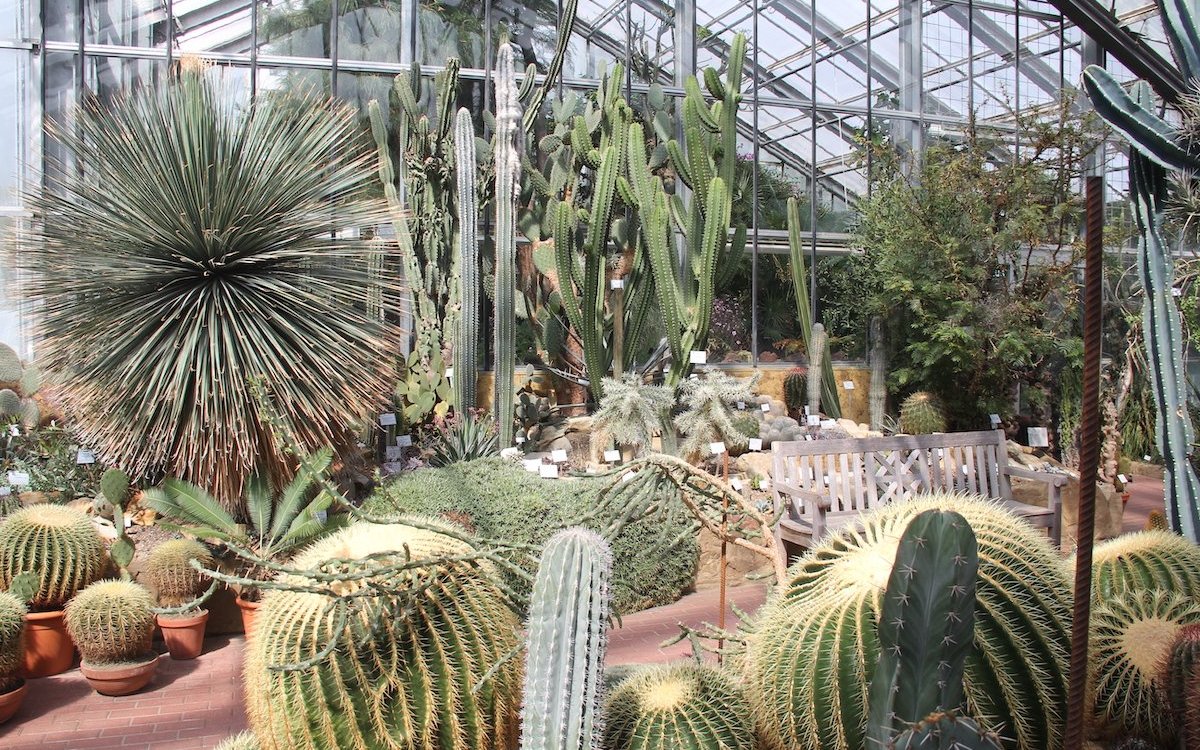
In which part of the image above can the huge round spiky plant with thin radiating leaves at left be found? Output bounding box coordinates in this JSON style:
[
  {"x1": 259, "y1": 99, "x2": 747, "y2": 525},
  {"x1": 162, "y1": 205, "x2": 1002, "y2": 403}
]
[{"x1": 18, "y1": 60, "x2": 397, "y2": 508}]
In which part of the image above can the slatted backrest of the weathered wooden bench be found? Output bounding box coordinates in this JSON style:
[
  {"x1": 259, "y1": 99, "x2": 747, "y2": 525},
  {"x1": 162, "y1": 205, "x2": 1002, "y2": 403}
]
[{"x1": 772, "y1": 430, "x2": 1012, "y2": 512}]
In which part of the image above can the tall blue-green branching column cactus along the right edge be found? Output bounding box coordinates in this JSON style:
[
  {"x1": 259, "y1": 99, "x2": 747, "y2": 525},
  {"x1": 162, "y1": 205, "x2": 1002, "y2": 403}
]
[{"x1": 1084, "y1": 0, "x2": 1200, "y2": 542}]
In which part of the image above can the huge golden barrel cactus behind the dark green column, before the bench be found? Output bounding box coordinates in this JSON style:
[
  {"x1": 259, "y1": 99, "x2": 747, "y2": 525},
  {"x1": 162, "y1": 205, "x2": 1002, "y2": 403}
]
[{"x1": 744, "y1": 494, "x2": 1070, "y2": 750}]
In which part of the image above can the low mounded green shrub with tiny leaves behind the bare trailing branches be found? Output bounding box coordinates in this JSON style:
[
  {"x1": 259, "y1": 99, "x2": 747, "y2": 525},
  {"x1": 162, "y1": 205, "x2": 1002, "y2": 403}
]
[{"x1": 365, "y1": 458, "x2": 698, "y2": 613}]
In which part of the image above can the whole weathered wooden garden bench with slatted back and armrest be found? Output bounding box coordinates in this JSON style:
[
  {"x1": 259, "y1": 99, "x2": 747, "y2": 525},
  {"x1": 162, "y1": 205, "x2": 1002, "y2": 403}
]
[{"x1": 770, "y1": 430, "x2": 1068, "y2": 556}]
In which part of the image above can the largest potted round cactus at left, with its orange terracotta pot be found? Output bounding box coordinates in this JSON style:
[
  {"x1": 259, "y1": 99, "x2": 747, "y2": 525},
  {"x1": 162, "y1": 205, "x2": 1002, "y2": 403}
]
[{"x1": 0, "y1": 505, "x2": 104, "y2": 677}]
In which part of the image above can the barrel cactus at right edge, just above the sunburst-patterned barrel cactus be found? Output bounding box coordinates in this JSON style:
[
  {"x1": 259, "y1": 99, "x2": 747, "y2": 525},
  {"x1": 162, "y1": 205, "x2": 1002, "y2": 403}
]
[{"x1": 1084, "y1": 532, "x2": 1200, "y2": 601}]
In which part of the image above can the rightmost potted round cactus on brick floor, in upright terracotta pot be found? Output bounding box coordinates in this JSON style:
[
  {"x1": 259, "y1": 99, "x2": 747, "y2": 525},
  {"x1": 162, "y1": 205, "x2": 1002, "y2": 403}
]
[{"x1": 145, "y1": 539, "x2": 212, "y2": 659}]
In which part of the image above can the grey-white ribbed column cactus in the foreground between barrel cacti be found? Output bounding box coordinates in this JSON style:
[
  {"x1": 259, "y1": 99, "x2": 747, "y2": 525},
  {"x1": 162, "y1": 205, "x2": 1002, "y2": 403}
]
[{"x1": 521, "y1": 528, "x2": 612, "y2": 750}]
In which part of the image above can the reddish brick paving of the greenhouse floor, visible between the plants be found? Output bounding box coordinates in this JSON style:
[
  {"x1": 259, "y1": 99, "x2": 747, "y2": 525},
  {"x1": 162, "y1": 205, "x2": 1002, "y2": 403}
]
[{"x1": 0, "y1": 478, "x2": 1163, "y2": 750}]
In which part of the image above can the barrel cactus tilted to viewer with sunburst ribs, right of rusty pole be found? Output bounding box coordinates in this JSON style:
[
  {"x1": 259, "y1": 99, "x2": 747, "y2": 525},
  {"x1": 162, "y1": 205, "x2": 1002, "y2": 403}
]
[{"x1": 1090, "y1": 589, "x2": 1200, "y2": 743}]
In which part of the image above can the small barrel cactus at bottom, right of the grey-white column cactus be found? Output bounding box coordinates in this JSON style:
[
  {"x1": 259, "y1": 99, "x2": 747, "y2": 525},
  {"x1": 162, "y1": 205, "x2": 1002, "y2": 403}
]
[{"x1": 602, "y1": 664, "x2": 755, "y2": 750}]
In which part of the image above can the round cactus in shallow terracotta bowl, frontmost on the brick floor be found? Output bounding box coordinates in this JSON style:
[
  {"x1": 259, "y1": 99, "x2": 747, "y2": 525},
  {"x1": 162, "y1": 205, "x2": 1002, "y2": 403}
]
[{"x1": 66, "y1": 581, "x2": 158, "y2": 696}]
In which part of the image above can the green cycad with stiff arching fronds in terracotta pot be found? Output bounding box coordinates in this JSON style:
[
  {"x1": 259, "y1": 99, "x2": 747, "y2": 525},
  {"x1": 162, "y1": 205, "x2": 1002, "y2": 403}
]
[{"x1": 145, "y1": 441, "x2": 349, "y2": 596}]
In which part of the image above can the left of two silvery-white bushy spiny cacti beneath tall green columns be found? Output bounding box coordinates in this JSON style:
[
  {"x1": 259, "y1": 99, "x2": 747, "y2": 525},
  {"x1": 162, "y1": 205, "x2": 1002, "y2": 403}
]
[{"x1": 592, "y1": 374, "x2": 674, "y2": 454}]
